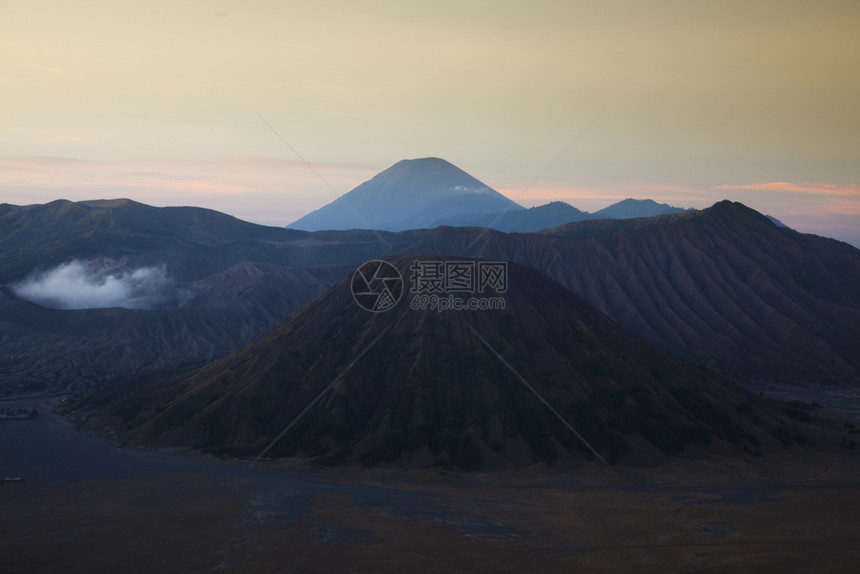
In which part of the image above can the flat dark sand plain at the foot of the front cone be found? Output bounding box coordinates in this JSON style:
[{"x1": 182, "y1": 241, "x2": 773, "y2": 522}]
[{"x1": 0, "y1": 401, "x2": 860, "y2": 572}]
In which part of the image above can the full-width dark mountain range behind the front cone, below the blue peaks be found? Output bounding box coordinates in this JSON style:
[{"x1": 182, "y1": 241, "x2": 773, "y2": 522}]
[{"x1": 0, "y1": 200, "x2": 860, "y2": 400}]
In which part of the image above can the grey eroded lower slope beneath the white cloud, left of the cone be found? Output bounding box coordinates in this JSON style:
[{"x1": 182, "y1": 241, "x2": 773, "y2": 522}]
[{"x1": 0, "y1": 262, "x2": 344, "y2": 395}]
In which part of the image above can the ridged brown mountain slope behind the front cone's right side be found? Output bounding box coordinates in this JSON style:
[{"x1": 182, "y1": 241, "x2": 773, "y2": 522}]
[{"x1": 409, "y1": 201, "x2": 860, "y2": 384}]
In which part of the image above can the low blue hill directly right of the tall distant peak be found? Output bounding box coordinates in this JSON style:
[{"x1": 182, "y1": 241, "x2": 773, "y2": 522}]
[{"x1": 433, "y1": 201, "x2": 591, "y2": 233}]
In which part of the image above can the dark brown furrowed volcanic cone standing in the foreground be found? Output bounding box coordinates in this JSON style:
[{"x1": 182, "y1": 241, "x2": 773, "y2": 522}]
[{"x1": 75, "y1": 258, "x2": 814, "y2": 468}]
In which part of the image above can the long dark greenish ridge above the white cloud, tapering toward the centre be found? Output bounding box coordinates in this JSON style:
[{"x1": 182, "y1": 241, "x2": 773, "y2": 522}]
[{"x1": 0, "y1": 199, "x2": 430, "y2": 284}]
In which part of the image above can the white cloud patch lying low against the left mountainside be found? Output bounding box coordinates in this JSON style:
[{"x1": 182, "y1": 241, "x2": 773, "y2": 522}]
[{"x1": 13, "y1": 259, "x2": 187, "y2": 309}]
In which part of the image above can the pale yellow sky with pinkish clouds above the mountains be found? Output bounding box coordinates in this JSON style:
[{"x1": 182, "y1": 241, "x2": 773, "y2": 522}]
[{"x1": 0, "y1": 0, "x2": 860, "y2": 246}]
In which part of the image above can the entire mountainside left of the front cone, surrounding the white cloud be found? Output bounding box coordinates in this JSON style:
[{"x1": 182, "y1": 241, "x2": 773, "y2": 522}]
[{"x1": 0, "y1": 199, "x2": 430, "y2": 394}]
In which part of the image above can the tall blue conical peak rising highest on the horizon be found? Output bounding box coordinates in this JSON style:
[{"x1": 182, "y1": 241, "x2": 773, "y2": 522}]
[{"x1": 288, "y1": 157, "x2": 524, "y2": 231}]
